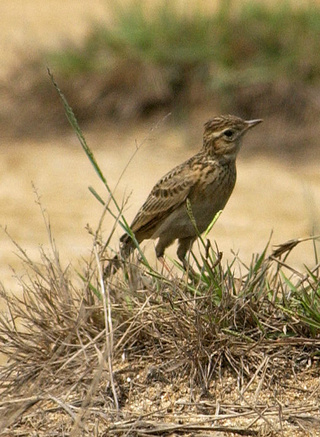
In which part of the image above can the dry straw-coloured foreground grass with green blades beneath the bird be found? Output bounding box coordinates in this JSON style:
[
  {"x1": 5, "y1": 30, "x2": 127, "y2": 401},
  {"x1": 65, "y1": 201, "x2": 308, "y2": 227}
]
[{"x1": 0, "y1": 215, "x2": 320, "y2": 435}]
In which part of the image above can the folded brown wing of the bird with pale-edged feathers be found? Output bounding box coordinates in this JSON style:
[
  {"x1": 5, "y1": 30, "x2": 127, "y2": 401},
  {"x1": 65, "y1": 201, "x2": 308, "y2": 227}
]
[{"x1": 125, "y1": 160, "x2": 198, "y2": 240}]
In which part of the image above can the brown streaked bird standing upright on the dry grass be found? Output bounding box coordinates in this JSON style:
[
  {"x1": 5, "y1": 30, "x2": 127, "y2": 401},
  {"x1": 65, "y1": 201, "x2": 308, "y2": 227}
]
[{"x1": 104, "y1": 115, "x2": 262, "y2": 277}]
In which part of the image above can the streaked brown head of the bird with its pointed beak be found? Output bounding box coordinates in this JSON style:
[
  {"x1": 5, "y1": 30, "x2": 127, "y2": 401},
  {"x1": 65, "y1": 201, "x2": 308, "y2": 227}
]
[{"x1": 203, "y1": 115, "x2": 262, "y2": 160}]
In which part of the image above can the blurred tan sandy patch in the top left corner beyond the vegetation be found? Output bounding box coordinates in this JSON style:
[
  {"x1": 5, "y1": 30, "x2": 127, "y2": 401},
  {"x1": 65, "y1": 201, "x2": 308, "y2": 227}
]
[{"x1": 0, "y1": 0, "x2": 107, "y2": 78}]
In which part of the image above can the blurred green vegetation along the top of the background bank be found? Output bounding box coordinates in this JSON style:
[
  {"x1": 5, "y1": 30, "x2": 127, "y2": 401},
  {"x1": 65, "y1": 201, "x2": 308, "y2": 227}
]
[{"x1": 48, "y1": 0, "x2": 320, "y2": 88}]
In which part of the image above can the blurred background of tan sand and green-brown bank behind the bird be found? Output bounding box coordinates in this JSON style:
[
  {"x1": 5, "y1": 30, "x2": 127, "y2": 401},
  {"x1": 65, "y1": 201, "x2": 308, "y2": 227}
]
[{"x1": 0, "y1": 0, "x2": 320, "y2": 290}]
